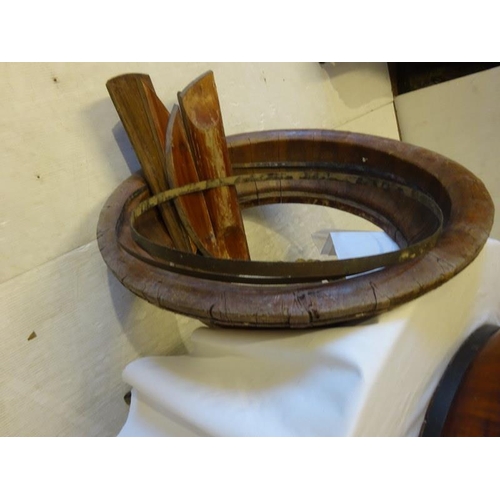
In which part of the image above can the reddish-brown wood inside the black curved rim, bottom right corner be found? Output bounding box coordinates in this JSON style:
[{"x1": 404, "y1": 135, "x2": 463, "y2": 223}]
[{"x1": 441, "y1": 330, "x2": 500, "y2": 437}]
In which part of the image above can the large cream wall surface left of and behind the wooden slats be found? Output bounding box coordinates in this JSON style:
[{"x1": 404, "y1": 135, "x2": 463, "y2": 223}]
[{"x1": 0, "y1": 63, "x2": 398, "y2": 436}]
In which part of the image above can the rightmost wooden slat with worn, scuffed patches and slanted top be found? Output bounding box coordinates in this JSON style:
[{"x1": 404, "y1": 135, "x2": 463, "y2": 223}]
[{"x1": 178, "y1": 71, "x2": 250, "y2": 260}]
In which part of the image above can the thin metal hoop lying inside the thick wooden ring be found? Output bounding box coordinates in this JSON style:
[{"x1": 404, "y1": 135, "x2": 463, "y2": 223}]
[{"x1": 127, "y1": 167, "x2": 444, "y2": 285}]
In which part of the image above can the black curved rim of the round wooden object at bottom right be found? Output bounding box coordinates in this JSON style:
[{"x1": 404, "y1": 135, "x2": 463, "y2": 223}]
[{"x1": 420, "y1": 324, "x2": 499, "y2": 437}]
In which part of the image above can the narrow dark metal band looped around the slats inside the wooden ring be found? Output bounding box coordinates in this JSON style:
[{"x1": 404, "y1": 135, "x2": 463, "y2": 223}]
[{"x1": 127, "y1": 170, "x2": 443, "y2": 285}]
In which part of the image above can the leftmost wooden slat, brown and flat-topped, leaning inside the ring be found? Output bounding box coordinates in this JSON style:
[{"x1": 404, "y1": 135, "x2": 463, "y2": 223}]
[{"x1": 106, "y1": 73, "x2": 193, "y2": 252}]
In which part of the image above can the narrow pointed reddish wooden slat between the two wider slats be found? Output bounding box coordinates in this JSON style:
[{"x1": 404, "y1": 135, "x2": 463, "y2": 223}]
[{"x1": 166, "y1": 106, "x2": 221, "y2": 258}]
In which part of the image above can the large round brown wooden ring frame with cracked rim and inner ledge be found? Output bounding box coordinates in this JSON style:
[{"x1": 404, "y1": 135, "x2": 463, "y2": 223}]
[{"x1": 97, "y1": 130, "x2": 494, "y2": 328}]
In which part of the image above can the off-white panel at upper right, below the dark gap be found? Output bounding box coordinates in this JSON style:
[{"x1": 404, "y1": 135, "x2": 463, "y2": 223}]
[{"x1": 395, "y1": 67, "x2": 500, "y2": 239}]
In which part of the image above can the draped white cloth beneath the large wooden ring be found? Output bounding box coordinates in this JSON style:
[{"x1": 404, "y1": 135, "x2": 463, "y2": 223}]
[{"x1": 120, "y1": 240, "x2": 500, "y2": 436}]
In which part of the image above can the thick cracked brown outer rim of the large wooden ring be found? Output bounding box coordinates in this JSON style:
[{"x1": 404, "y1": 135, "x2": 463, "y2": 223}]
[{"x1": 99, "y1": 130, "x2": 494, "y2": 328}]
